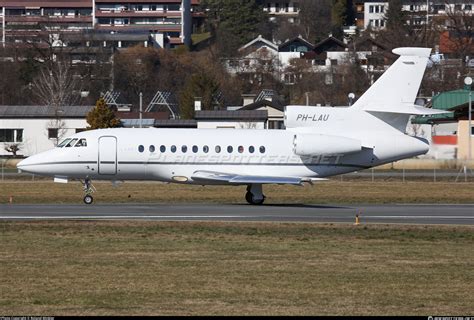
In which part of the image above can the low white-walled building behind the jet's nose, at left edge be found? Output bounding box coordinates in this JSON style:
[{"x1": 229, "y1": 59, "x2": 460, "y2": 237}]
[{"x1": 0, "y1": 106, "x2": 93, "y2": 156}]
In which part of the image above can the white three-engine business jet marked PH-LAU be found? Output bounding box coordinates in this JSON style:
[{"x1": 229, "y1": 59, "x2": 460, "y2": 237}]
[{"x1": 17, "y1": 48, "x2": 445, "y2": 204}]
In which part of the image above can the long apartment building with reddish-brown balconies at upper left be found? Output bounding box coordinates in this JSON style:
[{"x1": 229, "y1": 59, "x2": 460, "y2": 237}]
[{"x1": 0, "y1": 0, "x2": 203, "y2": 46}]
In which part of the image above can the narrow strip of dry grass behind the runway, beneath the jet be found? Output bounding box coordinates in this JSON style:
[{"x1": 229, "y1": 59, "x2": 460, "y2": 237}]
[{"x1": 0, "y1": 180, "x2": 474, "y2": 204}]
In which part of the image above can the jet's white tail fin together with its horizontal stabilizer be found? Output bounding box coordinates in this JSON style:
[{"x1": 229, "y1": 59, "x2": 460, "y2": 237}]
[{"x1": 352, "y1": 48, "x2": 446, "y2": 132}]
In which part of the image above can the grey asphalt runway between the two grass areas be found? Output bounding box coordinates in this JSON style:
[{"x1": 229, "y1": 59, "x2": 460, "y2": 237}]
[{"x1": 0, "y1": 204, "x2": 474, "y2": 225}]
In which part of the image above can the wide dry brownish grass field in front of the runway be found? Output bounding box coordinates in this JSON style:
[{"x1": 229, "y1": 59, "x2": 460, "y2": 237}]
[{"x1": 0, "y1": 221, "x2": 474, "y2": 315}]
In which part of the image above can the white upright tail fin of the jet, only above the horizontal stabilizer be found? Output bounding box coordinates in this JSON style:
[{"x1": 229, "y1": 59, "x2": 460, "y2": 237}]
[{"x1": 353, "y1": 48, "x2": 431, "y2": 113}]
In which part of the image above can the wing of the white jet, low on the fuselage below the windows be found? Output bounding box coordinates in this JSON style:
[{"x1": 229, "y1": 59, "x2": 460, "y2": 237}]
[{"x1": 191, "y1": 171, "x2": 326, "y2": 185}]
